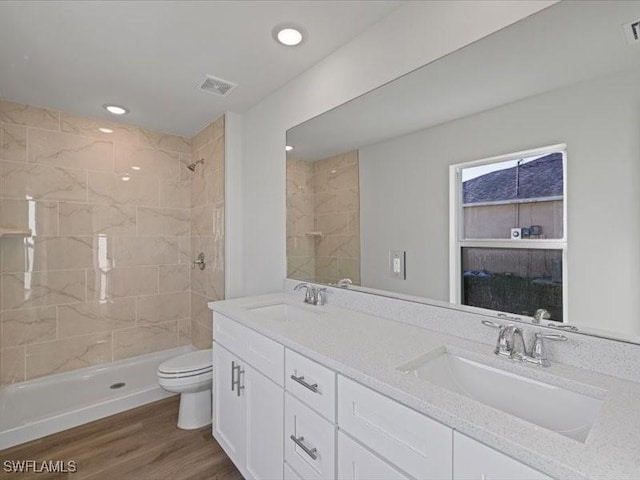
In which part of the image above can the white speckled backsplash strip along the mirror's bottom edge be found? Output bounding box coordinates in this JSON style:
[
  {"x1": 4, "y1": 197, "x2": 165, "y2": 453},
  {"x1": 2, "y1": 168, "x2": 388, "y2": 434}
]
[{"x1": 284, "y1": 278, "x2": 640, "y2": 382}]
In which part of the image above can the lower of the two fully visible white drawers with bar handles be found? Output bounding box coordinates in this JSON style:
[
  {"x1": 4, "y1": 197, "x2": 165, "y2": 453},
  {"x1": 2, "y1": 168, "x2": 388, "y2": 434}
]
[{"x1": 284, "y1": 393, "x2": 335, "y2": 480}]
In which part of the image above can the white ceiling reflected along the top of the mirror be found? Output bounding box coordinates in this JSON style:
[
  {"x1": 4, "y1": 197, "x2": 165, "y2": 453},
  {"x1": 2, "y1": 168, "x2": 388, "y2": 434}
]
[{"x1": 287, "y1": 1, "x2": 640, "y2": 160}]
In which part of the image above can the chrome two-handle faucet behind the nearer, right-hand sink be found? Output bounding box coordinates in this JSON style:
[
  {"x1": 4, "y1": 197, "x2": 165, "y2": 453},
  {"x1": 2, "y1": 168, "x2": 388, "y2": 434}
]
[{"x1": 482, "y1": 320, "x2": 567, "y2": 367}]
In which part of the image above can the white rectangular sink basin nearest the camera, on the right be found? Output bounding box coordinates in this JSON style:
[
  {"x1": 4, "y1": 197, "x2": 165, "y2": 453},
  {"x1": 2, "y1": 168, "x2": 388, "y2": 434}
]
[{"x1": 398, "y1": 351, "x2": 602, "y2": 443}]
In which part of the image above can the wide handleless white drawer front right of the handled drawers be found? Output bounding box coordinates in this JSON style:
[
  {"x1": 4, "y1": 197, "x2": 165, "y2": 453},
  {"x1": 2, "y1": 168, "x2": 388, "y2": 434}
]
[{"x1": 338, "y1": 375, "x2": 453, "y2": 480}]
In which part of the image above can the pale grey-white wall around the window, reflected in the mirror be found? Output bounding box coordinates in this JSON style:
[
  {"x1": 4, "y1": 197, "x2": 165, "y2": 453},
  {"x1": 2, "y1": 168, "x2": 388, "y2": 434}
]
[{"x1": 359, "y1": 69, "x2": 640, "y2": 335}]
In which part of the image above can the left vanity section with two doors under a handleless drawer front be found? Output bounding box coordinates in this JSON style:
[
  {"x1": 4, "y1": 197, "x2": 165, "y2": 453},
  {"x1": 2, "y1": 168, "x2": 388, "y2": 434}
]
[{"x1": 213, "y1": 315, "x2": 284, "y2": 480}]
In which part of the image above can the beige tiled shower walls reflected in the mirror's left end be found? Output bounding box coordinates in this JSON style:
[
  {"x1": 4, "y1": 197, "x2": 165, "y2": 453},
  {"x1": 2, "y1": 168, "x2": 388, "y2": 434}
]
[{"x1": 287, "y1": 150, "x2": 360, "y2": 284}]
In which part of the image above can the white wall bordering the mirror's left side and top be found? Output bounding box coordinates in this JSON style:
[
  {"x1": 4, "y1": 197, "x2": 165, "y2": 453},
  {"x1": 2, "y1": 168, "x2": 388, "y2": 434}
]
[{"x1": 226, "y1": 0, "x2": 555, "y2": 297}]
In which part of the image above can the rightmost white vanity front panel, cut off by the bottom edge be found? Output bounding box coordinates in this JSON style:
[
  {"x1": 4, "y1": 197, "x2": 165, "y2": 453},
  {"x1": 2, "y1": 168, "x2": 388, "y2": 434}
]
[{"x1": 453, "y1": 432, "x2": 552, "y2": 480}]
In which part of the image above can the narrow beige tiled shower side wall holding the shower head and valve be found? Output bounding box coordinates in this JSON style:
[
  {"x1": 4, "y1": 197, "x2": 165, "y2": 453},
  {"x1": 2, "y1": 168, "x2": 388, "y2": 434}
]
[{"x1": 191, "y1": 117, "x2": 225, "y2": 348}]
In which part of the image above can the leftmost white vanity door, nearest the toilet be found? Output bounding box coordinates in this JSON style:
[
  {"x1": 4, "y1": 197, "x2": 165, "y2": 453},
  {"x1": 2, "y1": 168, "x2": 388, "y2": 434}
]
[{"x1": 213, "y1": 344, "x2": 246, "y2": 465}]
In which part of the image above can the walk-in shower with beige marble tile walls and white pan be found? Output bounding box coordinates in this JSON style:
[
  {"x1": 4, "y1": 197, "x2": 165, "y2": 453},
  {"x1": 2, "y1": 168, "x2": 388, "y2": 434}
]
[{"x1": 0, "y1": 101, "x2": 225, "y2": 449}]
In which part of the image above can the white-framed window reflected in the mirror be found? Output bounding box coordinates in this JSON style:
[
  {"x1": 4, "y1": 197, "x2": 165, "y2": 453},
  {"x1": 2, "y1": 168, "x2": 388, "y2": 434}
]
[{"x1": 449, "y1": 144, "x2": 567, "y2": 322}]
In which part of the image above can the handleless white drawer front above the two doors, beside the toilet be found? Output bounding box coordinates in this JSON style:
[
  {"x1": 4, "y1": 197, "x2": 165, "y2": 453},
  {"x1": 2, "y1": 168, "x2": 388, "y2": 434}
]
[{"x1": 213, "y1": 312, "x2": 284, "y2": 387}]
